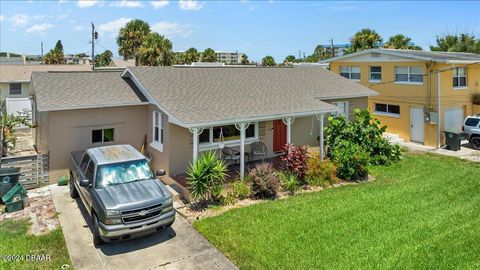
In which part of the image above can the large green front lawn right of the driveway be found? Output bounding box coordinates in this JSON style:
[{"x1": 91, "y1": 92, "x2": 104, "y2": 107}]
[{"x1": 194, "y1": 154, "x2": 480, "y2": 269}]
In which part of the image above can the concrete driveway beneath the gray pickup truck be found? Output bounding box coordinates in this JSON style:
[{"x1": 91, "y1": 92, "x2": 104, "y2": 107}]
[{"x1": 51, "y1": 185, "x2": 237, "y2": 270}]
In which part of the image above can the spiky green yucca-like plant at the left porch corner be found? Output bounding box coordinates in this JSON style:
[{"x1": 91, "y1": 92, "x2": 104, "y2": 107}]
[{"x1": 187, "y1": 151, "x2": 227, "y2": 200}]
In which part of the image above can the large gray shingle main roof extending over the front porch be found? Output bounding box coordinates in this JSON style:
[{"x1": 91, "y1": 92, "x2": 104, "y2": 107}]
[{"x1": 128, "y1": 67, "x2": 377, "y2": 127}]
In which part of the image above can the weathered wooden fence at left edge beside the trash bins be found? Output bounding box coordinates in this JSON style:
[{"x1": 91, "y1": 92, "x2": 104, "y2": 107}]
[{"x1": 0, "y1": 154, "x2": 48, "y2": 189}]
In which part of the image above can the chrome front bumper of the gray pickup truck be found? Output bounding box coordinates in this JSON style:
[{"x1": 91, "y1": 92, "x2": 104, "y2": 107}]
[{"x1": 99, "y1": 210, "x2": 175, "y2": 240}]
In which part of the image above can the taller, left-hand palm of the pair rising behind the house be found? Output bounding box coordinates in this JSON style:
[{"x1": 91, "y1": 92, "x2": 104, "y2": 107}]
[{"x1": 117, "y1": 19, "x2": 150, "y2": 66}]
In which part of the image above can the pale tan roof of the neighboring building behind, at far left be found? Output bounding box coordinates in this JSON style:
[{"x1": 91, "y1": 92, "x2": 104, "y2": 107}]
[{"x1": 0, "y1": 65, "x2": 92, "y2": 82}]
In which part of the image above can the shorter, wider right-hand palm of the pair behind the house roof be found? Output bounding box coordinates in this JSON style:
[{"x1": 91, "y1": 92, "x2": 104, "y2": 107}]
[{"x1": 138, "y1": 32, "x2": 175, "y2": 66}]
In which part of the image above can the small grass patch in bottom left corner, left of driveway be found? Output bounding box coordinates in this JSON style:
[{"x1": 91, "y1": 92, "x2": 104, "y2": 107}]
[{"x1": 0, "y1": 220, "x2": 72, "y2": 270}]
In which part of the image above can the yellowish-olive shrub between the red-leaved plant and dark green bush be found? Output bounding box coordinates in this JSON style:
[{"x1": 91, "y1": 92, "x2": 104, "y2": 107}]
[{"x1": 305, "y1": 152, "x2": 339, "y2": 187}]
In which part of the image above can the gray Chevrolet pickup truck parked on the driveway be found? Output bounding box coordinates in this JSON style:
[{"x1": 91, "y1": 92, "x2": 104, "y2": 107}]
[{"x1": 70, "y1": 145, "x2": 175, "y2": 244}]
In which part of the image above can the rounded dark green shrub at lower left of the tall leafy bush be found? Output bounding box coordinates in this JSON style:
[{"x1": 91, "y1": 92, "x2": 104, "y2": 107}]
[{"x1": 331, "y1": 141, "x2": 370, "y2": 181}]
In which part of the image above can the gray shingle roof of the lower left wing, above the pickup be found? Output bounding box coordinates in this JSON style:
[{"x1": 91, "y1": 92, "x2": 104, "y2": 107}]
[{"x1": 31, "y1": 71, "x2": 147, "y2": 111}]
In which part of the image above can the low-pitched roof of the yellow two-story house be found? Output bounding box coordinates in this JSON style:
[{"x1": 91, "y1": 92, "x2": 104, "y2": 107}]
[{"x1": 320, "y1": 48, "x2": 480, "y2": 63}]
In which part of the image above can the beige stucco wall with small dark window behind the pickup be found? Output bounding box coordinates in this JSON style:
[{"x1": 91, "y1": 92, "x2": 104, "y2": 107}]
[{"x1": 36, "y1": 106, "x2": 148, "y2": 181}]
